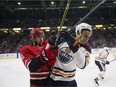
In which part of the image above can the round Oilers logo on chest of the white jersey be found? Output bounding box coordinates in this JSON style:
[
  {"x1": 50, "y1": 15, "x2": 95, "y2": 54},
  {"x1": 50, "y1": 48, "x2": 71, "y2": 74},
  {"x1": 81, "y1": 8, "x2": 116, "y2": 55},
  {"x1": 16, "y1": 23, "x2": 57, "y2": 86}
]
[{"x1": 58, "y1": 47, "x2": 73, "y2": 63}]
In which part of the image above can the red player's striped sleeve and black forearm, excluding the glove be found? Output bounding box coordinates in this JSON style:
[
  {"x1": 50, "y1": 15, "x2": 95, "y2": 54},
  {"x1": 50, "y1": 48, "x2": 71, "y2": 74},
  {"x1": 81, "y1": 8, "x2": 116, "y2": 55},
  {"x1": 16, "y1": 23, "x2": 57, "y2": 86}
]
[{"x1": 20, "y1": 48, "x2": 45, "y2": 72}]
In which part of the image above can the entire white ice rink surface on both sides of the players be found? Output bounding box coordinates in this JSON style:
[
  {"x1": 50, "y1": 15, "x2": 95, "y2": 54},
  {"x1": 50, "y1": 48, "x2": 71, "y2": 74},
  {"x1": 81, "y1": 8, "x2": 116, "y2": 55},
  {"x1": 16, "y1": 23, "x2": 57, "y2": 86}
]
[{"x1": 0, "y1": 54, "x2": 116, "y2": 87}]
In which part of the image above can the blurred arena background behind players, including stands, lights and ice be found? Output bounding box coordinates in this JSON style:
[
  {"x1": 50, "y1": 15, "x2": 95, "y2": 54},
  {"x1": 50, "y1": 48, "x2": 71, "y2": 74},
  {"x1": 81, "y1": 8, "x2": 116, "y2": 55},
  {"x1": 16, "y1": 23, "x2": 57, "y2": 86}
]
[{"x1": 0, "y1": 0, "x2": 116, "y2": 87}]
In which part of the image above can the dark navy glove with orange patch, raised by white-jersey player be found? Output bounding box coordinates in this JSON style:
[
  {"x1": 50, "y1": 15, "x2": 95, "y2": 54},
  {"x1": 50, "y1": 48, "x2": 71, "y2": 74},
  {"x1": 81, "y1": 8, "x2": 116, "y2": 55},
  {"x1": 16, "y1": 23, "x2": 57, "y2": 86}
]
[{"x1": 60, "y1": 31, "x2": 79, "y2": 53}]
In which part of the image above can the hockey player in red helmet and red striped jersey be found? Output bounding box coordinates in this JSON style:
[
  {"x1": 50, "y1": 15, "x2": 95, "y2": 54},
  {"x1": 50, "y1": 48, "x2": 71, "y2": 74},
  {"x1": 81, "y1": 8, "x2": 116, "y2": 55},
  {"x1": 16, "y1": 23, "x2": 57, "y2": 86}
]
[{"x1": 20, "y1": 28, "x2": 57, "y2": 87}]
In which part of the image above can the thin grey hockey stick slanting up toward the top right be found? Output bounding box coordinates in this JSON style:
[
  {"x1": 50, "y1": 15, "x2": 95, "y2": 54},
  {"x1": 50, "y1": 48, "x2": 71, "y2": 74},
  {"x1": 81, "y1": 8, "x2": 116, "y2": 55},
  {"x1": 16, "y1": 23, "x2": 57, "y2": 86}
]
[{"x1": 70, "y1": 0, "x2": 107, "y2": 30}]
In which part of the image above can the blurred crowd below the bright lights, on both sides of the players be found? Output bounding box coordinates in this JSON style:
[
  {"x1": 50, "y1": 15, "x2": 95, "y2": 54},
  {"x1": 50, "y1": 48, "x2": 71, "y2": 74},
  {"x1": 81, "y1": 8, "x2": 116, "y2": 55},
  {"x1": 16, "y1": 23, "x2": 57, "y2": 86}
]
[{"x1": 0, "y1": 29, "x2": 116, "y2": 54}]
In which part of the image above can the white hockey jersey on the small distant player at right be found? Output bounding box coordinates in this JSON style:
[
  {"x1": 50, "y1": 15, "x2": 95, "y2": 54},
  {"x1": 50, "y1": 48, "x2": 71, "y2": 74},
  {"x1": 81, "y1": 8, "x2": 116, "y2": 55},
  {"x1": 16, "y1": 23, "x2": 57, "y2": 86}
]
[{"x1": 95, "y1": 50, "x2": 109, "y2": 63}]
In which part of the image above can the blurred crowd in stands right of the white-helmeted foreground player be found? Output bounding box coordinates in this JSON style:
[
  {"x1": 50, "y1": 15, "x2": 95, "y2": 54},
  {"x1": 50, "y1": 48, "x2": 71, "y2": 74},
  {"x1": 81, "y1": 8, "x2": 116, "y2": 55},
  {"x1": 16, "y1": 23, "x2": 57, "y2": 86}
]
[{"x1": 89, "y1": 29, "x2": 116, "y2": 48}]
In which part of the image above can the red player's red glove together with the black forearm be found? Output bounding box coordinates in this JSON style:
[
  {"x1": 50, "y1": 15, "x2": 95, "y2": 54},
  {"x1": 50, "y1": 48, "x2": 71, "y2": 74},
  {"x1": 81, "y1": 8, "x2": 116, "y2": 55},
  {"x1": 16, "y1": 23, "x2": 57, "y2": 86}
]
[{"x1": 29, "y1": 47, "x2": 58, "y2": 72}]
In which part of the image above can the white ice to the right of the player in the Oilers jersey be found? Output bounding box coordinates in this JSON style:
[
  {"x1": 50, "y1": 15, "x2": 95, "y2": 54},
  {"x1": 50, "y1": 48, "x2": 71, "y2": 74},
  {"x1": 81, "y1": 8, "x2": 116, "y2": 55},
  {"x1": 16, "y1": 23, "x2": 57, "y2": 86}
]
[{"x1": 76, "y1": 54, "x2": 116, "y2": 87}]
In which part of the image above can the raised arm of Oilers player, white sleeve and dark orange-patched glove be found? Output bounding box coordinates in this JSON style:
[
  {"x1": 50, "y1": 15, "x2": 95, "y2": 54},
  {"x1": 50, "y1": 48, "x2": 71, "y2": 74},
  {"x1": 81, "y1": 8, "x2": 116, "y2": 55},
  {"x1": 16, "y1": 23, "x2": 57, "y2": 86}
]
[{"x1": 61, "y1": 31, "x2": 91, "y2": 69}]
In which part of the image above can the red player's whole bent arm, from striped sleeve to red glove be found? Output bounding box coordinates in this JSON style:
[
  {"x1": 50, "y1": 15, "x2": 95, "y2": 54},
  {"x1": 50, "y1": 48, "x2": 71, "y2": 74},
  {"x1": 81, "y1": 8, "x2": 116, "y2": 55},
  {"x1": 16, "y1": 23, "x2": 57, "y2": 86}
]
[{"x1": 20, "y1": 44, "x2": 57, "y2": 72}]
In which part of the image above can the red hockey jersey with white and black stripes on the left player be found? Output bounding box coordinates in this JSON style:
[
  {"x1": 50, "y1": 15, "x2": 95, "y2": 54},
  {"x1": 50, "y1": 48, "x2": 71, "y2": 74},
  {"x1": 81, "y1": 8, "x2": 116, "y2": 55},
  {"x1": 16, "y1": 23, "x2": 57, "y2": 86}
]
[{"x1": 20, "y1": 41, "x2": 58, "y2": 80}]
